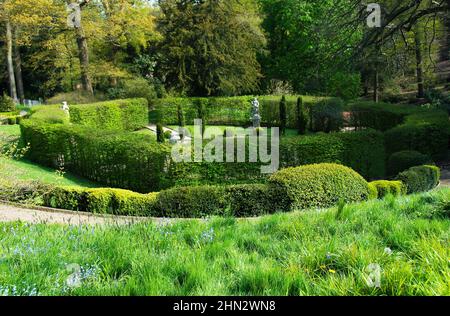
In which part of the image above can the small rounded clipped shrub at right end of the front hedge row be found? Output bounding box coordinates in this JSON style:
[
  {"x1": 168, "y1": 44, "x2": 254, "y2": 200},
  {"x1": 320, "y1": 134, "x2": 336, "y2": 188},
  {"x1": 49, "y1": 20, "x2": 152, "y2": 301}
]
[{"x1": 397, "y1": 165, "x2": 441, "y2": 194}]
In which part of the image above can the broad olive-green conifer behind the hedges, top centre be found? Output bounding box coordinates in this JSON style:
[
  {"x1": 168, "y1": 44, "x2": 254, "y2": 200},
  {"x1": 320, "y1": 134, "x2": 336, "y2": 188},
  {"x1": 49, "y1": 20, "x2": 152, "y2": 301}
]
[{"x1": 158, "y1": 0, "x2": 265, "y2": 96}]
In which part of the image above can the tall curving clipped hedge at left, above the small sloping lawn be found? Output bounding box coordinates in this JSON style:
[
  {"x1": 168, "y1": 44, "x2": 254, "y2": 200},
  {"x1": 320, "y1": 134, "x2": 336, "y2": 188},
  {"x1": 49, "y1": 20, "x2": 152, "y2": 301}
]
[{"x1": 21, "y1": 120, "x2": 170, "y2": 192}]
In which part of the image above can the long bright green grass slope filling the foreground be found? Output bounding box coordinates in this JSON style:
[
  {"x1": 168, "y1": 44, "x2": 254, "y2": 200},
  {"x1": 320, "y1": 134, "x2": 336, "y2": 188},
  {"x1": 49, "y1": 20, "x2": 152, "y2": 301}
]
[{"x1": 0, "y1": 189, "x2": 450, "y2": 295}]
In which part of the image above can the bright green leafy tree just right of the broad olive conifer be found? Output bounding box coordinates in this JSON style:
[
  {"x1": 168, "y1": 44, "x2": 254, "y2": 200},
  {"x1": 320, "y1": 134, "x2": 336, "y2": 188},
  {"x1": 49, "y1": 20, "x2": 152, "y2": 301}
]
[{"x1": 259, "y1": 0, "x2": 359, "y2": 93}]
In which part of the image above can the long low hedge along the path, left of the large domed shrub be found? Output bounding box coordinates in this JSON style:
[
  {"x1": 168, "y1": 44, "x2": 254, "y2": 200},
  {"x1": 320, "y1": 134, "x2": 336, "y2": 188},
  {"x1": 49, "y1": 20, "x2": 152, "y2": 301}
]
[{"x1": 43, "y1": 184, "x2": 271, "y2": 218}]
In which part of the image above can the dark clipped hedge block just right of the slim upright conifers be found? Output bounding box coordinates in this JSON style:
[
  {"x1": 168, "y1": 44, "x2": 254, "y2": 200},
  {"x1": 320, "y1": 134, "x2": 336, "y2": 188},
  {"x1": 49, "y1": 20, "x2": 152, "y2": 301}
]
[{"x1": 310, "y1": 99, "x2": 344, "y2": 133}]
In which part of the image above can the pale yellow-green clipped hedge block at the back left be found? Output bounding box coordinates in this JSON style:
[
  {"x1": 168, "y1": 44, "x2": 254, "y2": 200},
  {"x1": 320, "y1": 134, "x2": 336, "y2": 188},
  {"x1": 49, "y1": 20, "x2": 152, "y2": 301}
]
[{"x1": 70, "y1": 99, "x2": 148, "y2": 131}]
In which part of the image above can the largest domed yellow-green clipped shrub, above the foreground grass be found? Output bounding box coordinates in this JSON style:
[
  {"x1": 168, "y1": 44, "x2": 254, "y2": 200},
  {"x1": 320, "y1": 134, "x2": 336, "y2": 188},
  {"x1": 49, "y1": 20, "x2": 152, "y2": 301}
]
[{"x1": 269, "y1": 163, "x2": 370, "y2": 211}]
